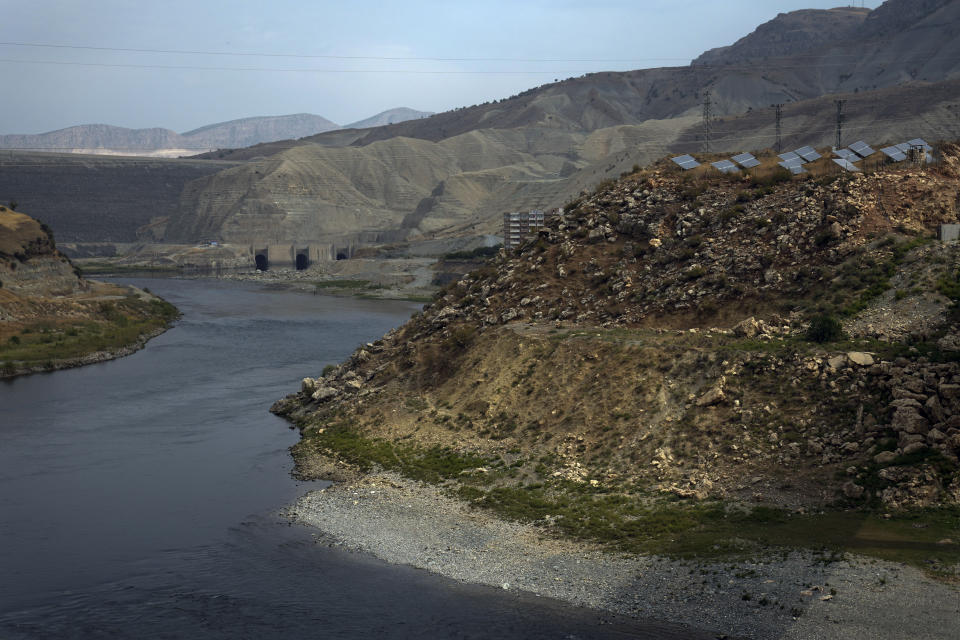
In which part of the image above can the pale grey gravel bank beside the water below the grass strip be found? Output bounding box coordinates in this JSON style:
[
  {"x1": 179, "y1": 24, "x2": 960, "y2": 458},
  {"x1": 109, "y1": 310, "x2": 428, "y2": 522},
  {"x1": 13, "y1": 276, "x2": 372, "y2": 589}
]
[{"x1": 287, "y1": 474, "x2": 960, "y2": 640}]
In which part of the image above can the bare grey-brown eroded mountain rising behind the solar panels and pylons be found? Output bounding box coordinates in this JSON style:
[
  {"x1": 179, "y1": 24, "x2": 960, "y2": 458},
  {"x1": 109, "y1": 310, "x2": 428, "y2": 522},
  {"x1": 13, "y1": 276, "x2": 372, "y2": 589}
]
[{"x1": 170, "y1": 0, "x2": 960, "y2": 248}]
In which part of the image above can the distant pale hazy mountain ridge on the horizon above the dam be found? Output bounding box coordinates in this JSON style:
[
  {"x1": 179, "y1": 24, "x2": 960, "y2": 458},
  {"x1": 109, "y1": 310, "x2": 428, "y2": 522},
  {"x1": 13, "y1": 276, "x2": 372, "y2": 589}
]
[{"x1": 0, "y1": 107, "x2": 429, "y2": 155}]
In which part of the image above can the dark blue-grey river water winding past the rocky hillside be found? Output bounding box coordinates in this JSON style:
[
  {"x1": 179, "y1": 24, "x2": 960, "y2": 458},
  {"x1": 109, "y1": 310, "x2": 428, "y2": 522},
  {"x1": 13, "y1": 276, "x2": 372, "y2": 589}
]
[{"x1": 0, "y1": 279, "x2": 680, "y2": 640}]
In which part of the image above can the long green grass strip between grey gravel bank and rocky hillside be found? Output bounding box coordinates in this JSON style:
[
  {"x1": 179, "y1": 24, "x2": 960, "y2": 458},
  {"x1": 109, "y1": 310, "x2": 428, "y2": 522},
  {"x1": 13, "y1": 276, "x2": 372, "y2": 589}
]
[{"x1": 292, "y1": 419, "x2": 960, "y2": 580}]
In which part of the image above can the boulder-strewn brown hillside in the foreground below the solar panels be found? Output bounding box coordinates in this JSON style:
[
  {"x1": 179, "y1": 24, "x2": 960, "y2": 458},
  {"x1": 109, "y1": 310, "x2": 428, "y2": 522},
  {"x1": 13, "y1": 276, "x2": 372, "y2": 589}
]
[{"x1": 275, "y1": 146, "x2": 960, "y2": 544}]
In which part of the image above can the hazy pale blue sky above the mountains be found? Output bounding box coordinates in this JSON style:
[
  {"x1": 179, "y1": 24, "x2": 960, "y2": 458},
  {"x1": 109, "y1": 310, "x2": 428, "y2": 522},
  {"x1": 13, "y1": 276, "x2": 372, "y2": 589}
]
[{"x1": 0, "y1": 0, "x2": 881, "y2": 133}]
